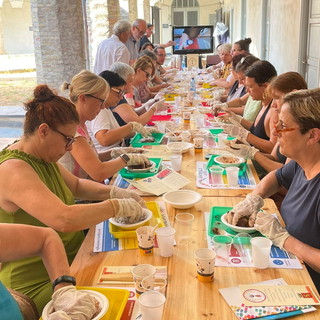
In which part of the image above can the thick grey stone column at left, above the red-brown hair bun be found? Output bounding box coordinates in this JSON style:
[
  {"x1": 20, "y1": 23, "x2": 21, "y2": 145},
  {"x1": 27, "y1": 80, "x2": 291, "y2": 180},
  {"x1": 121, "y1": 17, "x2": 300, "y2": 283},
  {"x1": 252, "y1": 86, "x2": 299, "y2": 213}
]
[{"x1": 31, "y1": 0, "x2": 86, "y2": 89}]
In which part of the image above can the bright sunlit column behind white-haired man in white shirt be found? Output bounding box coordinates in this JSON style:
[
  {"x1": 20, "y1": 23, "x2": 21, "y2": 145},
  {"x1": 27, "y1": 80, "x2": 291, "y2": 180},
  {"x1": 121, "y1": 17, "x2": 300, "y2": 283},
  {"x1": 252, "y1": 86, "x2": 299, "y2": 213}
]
[{"x1": 87, "y1": 0, "x2": 120, "y2": 68}]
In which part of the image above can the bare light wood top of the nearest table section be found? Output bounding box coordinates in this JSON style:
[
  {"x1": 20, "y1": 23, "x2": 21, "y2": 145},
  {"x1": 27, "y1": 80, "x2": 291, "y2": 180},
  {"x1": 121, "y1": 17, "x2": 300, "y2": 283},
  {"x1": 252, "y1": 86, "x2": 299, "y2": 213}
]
[{"x1": 71, "y1": 196, "x2": 320, "y2": 320}]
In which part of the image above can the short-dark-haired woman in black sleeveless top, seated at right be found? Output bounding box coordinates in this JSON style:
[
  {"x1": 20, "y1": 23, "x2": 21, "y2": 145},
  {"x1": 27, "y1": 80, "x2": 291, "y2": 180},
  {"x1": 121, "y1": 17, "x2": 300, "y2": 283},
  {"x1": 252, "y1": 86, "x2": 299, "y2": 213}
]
[{"x1": 225, "y1": 60, "x2": 277, "y2": 153}]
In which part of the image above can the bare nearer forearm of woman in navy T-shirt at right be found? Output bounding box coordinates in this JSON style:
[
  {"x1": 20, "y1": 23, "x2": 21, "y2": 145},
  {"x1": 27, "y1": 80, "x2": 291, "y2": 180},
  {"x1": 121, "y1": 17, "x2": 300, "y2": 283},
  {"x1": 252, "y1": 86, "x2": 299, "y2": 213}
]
[{"x1": 284, "y1": 236, "x2": 320, "y2": 273}]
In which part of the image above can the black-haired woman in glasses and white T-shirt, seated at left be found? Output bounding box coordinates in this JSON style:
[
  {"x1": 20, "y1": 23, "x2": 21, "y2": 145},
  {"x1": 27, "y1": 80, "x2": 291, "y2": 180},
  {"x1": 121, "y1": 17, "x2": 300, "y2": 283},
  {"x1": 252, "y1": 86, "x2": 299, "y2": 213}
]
[{"x1": 86, "y1": 70, "x2": 158, "y2": 154}]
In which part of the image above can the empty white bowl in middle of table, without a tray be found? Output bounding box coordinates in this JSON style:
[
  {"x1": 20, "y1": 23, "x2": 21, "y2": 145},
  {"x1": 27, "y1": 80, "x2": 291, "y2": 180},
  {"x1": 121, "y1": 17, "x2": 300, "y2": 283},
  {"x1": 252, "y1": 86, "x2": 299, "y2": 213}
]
[{"x1": 162, "y1": 190, "x2": 202, "y2": 209}]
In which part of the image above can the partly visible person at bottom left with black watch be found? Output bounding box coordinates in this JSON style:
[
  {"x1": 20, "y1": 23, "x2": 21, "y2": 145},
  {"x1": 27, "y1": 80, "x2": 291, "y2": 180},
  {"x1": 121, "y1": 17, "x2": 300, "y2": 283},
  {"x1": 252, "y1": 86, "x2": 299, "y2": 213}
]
[{"x1": 0, "y1": 223, "x2": 97, "y2": 320}]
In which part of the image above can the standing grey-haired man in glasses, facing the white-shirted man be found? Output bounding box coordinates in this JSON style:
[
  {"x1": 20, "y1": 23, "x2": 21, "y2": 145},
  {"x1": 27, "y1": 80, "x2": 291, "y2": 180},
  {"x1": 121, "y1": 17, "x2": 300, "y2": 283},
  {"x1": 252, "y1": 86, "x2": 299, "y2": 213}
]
[{"x1": 125, "y1": 19, "x2": 147, "y2": 65}]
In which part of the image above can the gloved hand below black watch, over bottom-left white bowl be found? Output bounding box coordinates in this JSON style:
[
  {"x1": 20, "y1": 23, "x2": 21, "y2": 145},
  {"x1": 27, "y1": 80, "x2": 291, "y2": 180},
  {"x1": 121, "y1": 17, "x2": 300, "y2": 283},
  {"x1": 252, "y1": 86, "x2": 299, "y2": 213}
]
[{"x1": 52, "y1": 286, "x2": 97, "y2": 320}]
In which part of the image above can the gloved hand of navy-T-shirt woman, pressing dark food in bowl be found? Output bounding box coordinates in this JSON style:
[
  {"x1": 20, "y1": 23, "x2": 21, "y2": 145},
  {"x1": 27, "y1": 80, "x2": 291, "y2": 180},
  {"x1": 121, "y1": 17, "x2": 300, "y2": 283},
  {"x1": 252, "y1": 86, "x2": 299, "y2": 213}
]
[{"x1": 226, "y1": 193, "x2": 264, "y2": 227}]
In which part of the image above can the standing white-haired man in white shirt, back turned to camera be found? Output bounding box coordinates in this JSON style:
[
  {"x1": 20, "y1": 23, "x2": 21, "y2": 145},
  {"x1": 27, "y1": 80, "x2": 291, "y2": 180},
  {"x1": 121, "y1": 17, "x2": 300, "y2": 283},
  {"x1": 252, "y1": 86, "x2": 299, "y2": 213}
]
[{"x1": 94, "y1": 20, "x2": 131, "y2": 74}]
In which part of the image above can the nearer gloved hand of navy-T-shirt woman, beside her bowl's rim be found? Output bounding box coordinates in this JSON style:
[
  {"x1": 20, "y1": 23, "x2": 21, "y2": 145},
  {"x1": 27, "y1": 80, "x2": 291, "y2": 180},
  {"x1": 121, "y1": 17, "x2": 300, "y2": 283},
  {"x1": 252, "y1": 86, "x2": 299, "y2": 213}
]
[{"x1": 254, "y1": 212, "x2": 290, "y2": 249}]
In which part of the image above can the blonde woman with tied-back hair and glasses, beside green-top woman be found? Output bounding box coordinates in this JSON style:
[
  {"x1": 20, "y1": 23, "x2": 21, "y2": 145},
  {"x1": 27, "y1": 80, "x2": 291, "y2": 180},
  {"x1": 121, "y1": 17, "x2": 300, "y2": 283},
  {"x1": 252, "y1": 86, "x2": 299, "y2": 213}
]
[{"x1": 59, "y1": 70, "x2": 148, "y2": 182}]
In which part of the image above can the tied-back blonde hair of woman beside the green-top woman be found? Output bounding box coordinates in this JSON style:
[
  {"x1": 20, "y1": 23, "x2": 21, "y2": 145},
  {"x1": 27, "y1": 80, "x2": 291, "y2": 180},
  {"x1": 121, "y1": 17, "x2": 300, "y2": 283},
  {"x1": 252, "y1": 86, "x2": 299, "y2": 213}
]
[{"x1": 61, "y1": 70, "x2": 110, "y2": 103}]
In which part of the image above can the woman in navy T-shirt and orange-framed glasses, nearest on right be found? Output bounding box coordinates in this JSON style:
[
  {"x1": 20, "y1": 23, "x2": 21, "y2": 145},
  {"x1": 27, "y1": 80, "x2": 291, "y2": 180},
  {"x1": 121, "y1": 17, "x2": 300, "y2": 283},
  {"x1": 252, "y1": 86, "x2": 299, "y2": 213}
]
[{"x1": 228, "y1": 89, "x2": 320, "y2": 291}]
